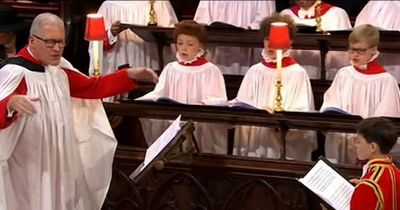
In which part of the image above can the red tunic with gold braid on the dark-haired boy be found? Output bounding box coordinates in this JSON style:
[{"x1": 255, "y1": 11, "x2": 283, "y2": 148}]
[{"x1": 350, "y1": 158, "x2": 400, "y2": 210}]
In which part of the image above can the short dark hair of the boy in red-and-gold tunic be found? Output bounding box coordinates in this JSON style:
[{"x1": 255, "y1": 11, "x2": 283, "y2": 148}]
[{"x1": 357, "y1": 117, "x2": 397, "y2": 154}]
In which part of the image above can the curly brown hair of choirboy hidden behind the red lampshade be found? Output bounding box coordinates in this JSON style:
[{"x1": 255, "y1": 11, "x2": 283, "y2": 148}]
[{"x1": 260, "y1": 12, "x2": 297, "y2": 40}]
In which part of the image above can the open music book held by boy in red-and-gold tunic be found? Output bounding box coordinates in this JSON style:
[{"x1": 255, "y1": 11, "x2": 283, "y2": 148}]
[{"x1": 298, "y1": 157, "x2": 355, "y2": 210}]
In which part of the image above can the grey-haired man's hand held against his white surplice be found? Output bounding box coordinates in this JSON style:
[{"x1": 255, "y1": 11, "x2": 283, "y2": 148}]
[{"x1": 8, "y1": 95, "x2": 39, "y2": 115}]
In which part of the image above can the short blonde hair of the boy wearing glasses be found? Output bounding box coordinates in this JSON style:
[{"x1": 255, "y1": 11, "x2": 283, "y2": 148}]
[{"x1": 349, "y1": 24, "x2": 379, "y2": 47}]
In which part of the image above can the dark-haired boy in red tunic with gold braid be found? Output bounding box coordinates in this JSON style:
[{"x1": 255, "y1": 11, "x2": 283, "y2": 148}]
[{"x1": 350, "y1": 118, "x2": 400, "y2": 210}]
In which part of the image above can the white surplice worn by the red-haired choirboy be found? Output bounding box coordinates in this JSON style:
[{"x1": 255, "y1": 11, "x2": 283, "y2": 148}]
[{"x1": 137, "y1": 61, "x2": 227, "y2": 154}]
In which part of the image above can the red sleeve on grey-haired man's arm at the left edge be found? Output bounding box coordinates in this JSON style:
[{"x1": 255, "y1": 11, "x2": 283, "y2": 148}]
[{"x1": 0, "y1": 79, "x2": 27, "y2": 129}]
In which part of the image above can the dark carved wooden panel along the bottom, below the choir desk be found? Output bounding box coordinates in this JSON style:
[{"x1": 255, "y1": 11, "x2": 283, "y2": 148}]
[{"x1": 103, "y1": 147, "x2": 360, "y2": 210}]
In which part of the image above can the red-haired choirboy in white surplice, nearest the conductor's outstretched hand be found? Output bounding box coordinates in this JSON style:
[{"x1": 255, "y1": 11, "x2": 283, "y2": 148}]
[{"x1": 138, "y1": 20, "x2": 227, "y2": 153}]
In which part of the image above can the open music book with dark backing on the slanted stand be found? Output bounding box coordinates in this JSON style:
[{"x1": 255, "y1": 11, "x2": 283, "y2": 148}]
[{"x1": 129, "y1": 115, "x2": 181, "y2": 181}]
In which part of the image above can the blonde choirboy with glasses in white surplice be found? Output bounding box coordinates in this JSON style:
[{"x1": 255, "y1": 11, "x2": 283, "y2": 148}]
[{"x1": 321, "y1": 24, "x2": 400, "y2": 163}]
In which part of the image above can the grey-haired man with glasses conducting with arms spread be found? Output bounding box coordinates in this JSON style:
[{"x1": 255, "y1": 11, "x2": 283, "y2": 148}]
[{"x1": 0, "y1": 13, "x2": 157, "y2": 210}]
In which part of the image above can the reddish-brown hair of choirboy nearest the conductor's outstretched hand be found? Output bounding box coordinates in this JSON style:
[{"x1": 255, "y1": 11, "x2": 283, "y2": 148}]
[{"x1": 173, "y1": 20, "x2": 207, "y2": 45}]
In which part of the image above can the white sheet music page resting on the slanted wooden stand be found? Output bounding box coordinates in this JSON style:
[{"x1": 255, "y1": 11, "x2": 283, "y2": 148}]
[{"x1": 141, "y1": 115, "x2": 181, "y2": 170}]
